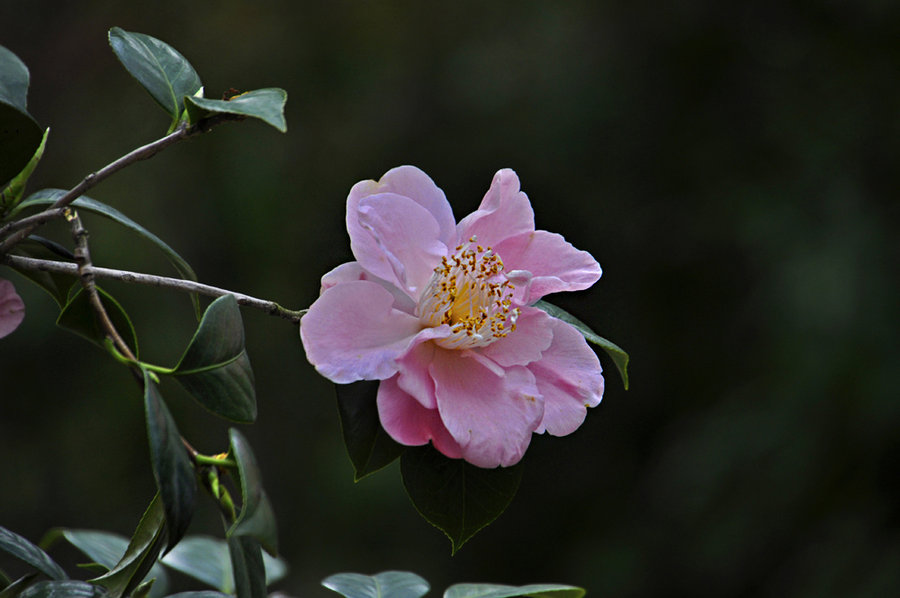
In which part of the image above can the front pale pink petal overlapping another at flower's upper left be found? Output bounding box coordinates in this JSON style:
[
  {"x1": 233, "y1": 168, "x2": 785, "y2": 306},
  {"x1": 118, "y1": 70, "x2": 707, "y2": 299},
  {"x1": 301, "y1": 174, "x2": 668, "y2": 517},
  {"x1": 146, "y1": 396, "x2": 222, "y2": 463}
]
[{"x1": 354, "y1": 193, "x2": 447, "y2": 299}]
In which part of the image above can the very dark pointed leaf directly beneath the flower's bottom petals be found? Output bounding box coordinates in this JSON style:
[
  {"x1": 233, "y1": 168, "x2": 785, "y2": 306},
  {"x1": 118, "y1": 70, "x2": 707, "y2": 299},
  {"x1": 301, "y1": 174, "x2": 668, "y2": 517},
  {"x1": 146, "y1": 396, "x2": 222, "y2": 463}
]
[{"x1": 400, "y1": 445, "x2": 523, "y2": 553}]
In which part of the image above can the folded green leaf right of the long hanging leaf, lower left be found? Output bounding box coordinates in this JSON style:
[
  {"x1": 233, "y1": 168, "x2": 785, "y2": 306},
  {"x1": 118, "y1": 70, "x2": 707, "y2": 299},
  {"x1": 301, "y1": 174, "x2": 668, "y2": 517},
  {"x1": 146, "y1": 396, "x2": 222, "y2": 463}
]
[{"x1": 226, "y1": 428, "x2": 278, "y2": 556}]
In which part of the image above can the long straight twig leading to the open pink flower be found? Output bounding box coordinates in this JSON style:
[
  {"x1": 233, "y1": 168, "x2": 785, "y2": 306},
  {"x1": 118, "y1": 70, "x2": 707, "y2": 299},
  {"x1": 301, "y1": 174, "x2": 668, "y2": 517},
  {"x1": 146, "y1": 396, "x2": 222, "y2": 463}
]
[{"x1": 0, "y1": 255, "x2": 306, "y2": 324}]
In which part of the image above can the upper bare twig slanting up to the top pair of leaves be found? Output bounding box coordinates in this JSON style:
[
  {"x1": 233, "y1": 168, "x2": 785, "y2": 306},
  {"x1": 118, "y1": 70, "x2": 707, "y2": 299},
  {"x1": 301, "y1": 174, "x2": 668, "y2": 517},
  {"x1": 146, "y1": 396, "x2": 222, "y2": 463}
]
[{"x1": 0, "y1": 114, "x2": 239, "y2": 255}]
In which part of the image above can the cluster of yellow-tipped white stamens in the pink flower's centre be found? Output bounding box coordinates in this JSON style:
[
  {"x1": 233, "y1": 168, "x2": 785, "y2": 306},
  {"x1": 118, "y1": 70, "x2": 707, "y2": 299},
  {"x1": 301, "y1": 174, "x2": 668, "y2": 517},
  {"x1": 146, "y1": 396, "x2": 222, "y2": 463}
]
[{"x1": 419, "y1": 237, "x2": 520, "y2": 349}]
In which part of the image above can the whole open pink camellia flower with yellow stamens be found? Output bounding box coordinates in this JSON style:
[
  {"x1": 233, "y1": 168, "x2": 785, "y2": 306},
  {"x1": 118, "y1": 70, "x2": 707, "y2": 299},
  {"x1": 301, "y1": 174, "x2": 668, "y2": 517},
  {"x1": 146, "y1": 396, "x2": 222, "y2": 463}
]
[{"x1": 300, "y1": 166, "x2": 603, "y2": 468}]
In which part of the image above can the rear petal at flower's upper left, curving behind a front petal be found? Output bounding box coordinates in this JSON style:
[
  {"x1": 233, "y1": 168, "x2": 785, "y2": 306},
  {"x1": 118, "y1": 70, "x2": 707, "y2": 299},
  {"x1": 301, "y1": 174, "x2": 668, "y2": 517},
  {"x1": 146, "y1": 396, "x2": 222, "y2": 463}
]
[{"x1": 347, "y1": 166, "x2": 457, "y2": 290}]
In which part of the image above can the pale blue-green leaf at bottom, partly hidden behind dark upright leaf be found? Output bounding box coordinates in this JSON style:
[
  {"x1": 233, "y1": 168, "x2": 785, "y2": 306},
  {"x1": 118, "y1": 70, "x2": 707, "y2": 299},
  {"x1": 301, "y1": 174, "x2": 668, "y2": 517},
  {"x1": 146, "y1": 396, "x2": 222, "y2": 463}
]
[{"x1": 161, "y1": 536, "x2": 287, "y2": 594}]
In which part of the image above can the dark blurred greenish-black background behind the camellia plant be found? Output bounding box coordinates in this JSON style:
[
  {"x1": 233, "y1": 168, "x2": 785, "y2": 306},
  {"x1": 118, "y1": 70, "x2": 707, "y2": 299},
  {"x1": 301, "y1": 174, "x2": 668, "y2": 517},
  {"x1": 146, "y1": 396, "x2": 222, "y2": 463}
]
[{"x1": 0, "y1": 0, "x2": 900, "y2": 597}]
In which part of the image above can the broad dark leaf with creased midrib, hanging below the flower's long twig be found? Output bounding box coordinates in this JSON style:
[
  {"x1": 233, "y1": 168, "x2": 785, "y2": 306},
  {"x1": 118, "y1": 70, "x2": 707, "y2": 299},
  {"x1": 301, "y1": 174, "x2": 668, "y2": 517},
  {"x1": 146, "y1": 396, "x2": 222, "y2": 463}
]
[{"x1": 173, "y1": 295, "x2": 256, "y2": 422}]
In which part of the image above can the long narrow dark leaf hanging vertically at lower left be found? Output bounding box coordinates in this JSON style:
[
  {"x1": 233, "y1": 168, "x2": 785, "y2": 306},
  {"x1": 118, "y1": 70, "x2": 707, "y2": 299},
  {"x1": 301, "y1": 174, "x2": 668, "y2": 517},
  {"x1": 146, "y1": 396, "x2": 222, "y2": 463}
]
[{"x1": 144, "y1": 370, "x2": 197, "y2": 550}]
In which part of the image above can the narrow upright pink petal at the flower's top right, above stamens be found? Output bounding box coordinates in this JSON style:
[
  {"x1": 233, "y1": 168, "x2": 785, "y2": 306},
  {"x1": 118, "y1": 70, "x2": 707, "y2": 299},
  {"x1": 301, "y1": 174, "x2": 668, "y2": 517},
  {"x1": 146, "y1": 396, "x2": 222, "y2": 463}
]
[{"x1": 456, "y1": 168, "x2": 534, "y2": 250}]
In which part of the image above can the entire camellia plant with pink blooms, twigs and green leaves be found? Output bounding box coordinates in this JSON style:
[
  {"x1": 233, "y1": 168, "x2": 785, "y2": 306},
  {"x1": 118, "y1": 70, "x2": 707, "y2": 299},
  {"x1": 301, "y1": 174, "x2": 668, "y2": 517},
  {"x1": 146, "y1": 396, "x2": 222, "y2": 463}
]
[{"x1": 0, "y1": 28, "x2": 628, "y2": 598}]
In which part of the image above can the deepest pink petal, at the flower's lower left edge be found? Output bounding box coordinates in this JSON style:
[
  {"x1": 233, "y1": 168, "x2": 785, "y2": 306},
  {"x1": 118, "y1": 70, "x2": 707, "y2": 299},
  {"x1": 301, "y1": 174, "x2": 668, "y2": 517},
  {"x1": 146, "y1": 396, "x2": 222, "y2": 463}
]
[{"x1": 377, "y1": 376, "x2": 462, "y2": 459}]
